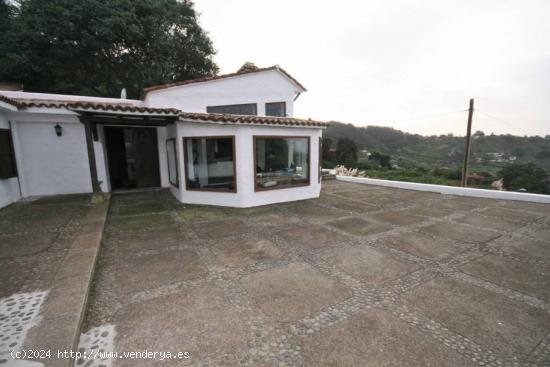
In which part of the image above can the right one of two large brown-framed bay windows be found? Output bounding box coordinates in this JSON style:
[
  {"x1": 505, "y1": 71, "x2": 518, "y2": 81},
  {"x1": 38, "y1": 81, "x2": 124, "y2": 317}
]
[{"x1": 254, "y1": 136, "x2": 309, "y2": 191}]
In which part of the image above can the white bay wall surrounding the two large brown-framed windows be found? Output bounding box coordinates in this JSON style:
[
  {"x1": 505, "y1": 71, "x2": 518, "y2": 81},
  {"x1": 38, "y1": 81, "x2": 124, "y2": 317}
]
[{"x1": 173, "y1": 122, "x2": 321, "y2": 208}]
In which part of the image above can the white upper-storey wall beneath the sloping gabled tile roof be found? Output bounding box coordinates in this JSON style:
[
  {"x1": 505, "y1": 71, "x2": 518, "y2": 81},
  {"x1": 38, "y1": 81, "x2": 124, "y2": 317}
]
[{"x1": 145, "y1": 70, "x2": 299, "y2": 117}]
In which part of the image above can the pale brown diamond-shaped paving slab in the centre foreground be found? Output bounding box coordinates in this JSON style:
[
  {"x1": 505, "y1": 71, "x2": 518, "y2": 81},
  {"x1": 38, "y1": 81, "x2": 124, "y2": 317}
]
[{"x1": 242, "y1": 263, "x2": 351, "y2": 322}]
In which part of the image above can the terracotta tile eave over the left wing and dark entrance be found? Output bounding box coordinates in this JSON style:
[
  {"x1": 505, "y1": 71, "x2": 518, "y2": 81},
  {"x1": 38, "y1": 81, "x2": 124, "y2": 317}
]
[{"x1": 9, "y1": 96, "x2": 181, "y2": 115}]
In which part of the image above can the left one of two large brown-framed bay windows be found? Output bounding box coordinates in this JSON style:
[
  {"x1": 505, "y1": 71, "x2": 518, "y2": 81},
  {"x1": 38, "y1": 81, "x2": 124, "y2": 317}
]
[{"x1": 183, "y1": 136, "x2": 237, "y2": 192}]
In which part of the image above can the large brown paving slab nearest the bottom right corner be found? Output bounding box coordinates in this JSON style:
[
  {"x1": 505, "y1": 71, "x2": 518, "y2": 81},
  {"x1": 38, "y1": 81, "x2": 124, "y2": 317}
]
[{"x1": 403, "y1": 278, "x2": 550, "y2": 358}]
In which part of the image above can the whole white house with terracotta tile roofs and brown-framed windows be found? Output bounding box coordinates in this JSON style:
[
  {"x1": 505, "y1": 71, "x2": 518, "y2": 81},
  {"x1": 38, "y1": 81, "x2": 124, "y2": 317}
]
[{"x1": 0, "y1": 63, "x2": 326, "y2": 207}]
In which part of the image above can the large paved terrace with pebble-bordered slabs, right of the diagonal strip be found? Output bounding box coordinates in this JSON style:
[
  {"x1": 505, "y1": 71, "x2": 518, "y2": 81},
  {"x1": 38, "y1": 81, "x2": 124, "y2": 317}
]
[{"x1": 79, "y1": 181, "x2": 550, "y2": 366}]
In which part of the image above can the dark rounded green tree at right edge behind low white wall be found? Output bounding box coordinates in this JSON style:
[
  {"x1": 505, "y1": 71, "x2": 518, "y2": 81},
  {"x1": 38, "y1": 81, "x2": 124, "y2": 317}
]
[{"x1": 499, "y1": 163, "x2": 550, "y2": 194}]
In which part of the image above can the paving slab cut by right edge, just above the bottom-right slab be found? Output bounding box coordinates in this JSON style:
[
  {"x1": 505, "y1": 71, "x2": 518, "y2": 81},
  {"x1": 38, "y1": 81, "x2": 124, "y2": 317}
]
[{"x1": 461, "y1": 255, "x2": 550, "y2": 302}]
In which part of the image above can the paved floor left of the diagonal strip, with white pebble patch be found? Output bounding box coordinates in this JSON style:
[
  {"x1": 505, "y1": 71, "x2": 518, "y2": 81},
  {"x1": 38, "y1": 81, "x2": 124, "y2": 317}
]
[{"x1": 0, "y1": 195, "x2": 90, "y2": 366}]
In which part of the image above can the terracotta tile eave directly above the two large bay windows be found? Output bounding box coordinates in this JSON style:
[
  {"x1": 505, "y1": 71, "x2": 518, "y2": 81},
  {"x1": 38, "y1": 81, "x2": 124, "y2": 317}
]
[{"x1": 180, "y1": 112, "x2": 328, "y2": 127}]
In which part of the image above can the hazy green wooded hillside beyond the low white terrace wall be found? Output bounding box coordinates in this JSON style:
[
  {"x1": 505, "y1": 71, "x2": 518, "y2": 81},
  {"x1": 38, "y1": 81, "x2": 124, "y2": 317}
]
[{"x1": 323, "y1": 122, "x2": 550, "y2": 193}]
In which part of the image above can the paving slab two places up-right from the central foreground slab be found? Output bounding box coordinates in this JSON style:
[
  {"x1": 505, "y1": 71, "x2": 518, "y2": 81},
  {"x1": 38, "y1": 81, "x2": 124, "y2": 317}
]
[{"x1": 377, "y1": 231, "x2": 471, "y2": 260}]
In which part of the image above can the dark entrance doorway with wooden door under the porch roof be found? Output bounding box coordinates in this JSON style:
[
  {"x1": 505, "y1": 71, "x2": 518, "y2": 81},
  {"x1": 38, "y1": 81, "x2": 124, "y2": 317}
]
[{"x1": 105, "y1": 127, "x2": 160, "y2": 190}]
